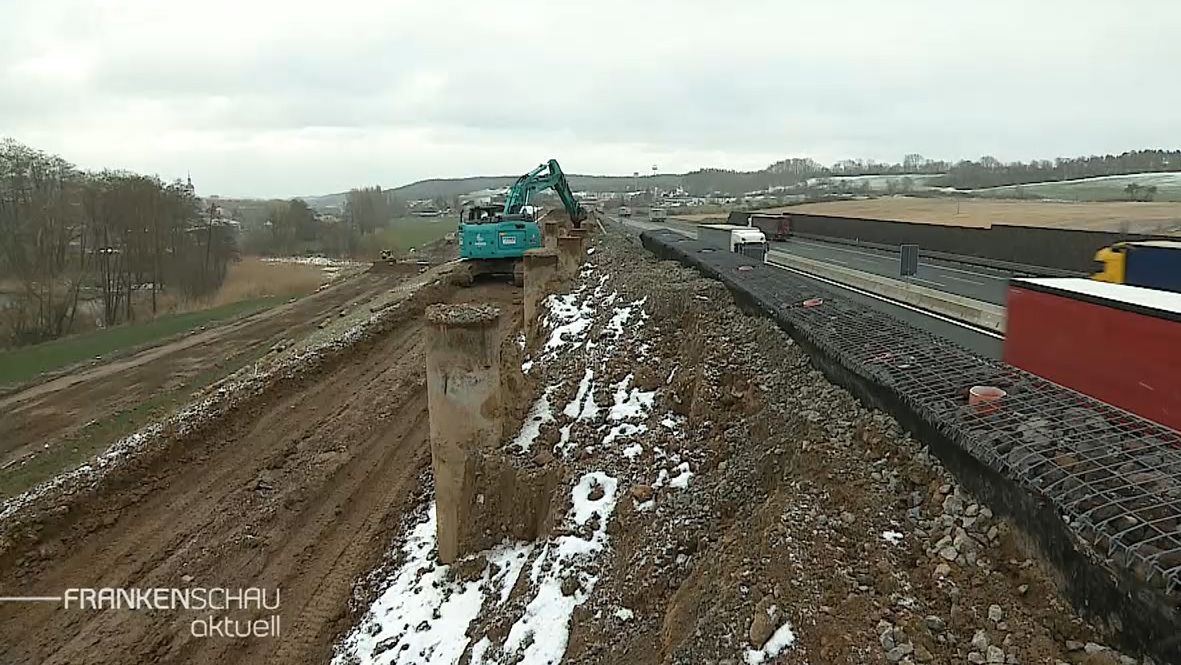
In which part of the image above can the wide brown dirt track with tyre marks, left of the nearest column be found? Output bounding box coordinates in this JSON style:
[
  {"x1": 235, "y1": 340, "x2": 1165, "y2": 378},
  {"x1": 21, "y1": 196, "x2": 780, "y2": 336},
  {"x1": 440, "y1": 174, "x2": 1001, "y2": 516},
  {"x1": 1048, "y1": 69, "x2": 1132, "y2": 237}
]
[{"x1": 0, "y1": 281, "x2": 520, "y2": 665}]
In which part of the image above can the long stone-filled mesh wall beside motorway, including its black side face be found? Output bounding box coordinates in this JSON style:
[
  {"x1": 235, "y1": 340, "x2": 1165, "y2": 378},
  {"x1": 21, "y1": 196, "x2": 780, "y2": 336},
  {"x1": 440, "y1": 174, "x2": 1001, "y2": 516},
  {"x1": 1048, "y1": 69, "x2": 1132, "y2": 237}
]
[{"x1": 641, "y1": 230, "x2": 1181, "y2": 663}]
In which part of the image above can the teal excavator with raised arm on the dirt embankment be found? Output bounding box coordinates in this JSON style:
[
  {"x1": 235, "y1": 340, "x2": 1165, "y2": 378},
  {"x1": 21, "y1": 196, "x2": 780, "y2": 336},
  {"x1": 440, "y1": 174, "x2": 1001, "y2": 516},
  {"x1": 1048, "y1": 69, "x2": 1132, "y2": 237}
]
[{"x1": 457, "y1": 159, "x2": 587, "y2": 285}]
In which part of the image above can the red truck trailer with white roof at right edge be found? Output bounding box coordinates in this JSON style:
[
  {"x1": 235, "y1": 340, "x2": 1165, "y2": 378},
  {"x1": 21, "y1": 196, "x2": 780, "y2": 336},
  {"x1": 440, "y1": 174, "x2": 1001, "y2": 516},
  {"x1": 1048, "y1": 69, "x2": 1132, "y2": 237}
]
[{"x1": 1004, "y1": 278, "x2": 1181, "y2": 430}]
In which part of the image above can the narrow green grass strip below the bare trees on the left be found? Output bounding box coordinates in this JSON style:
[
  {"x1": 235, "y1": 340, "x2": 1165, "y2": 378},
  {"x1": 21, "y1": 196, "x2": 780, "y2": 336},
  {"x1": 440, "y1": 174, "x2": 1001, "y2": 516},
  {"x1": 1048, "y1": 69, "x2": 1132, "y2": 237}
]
[{"x1": 0, "y1": 296, "x2": 287, "y2": 386}]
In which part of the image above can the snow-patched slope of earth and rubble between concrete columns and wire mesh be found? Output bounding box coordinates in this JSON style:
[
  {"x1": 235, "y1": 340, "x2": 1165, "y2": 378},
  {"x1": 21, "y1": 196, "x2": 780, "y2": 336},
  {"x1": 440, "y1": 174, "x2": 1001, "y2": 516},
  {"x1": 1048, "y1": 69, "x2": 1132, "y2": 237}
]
[{"x1": 337, "y1": 230, "x2": 1147, "y2": 665}]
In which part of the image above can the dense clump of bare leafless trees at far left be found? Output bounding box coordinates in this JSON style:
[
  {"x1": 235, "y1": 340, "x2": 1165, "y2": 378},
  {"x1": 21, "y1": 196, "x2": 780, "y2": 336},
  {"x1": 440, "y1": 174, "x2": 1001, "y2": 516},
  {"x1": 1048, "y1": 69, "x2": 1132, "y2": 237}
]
[{"x1": 0, "y1": 139, "x2": 237, "y2": 345}]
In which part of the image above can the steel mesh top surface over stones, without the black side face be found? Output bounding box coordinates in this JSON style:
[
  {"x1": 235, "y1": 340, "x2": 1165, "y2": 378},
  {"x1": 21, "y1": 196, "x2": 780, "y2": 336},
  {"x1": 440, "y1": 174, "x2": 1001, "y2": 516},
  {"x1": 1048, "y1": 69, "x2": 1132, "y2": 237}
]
[{"x1": 651, "y1": 232, "x2": 1181, "y2": 604}]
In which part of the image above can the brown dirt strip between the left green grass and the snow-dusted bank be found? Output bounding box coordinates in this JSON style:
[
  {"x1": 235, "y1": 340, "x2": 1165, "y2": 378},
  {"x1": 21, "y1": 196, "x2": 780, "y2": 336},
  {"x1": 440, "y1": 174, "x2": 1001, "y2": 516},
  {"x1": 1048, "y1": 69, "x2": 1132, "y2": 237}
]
[{"x1": 0, "y1": 275, "x2": 400, "y2": 467}]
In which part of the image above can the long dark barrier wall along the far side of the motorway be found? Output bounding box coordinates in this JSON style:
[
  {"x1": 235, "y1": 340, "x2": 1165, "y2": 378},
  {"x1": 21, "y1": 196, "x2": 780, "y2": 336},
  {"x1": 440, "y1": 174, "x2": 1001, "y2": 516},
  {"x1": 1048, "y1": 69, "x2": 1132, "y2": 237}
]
[{"x1": 729, "y1": 211, "x2": 1164, "y2": 273}]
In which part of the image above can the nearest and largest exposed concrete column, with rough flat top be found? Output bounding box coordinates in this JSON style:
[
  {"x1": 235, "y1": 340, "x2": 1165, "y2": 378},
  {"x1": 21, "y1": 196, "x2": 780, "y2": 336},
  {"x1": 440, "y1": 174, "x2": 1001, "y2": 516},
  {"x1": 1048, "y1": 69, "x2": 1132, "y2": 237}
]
[{"x1": 426, "y1": 305, "x2": 503, "y2": 563}]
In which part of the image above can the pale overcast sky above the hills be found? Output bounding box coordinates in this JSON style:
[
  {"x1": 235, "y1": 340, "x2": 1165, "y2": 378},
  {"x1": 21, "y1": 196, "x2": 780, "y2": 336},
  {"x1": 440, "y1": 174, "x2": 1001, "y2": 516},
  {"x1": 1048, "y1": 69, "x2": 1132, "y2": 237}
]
[{"x1": 0, "y1": 0, "x2": 1181, "y2": 196}]
